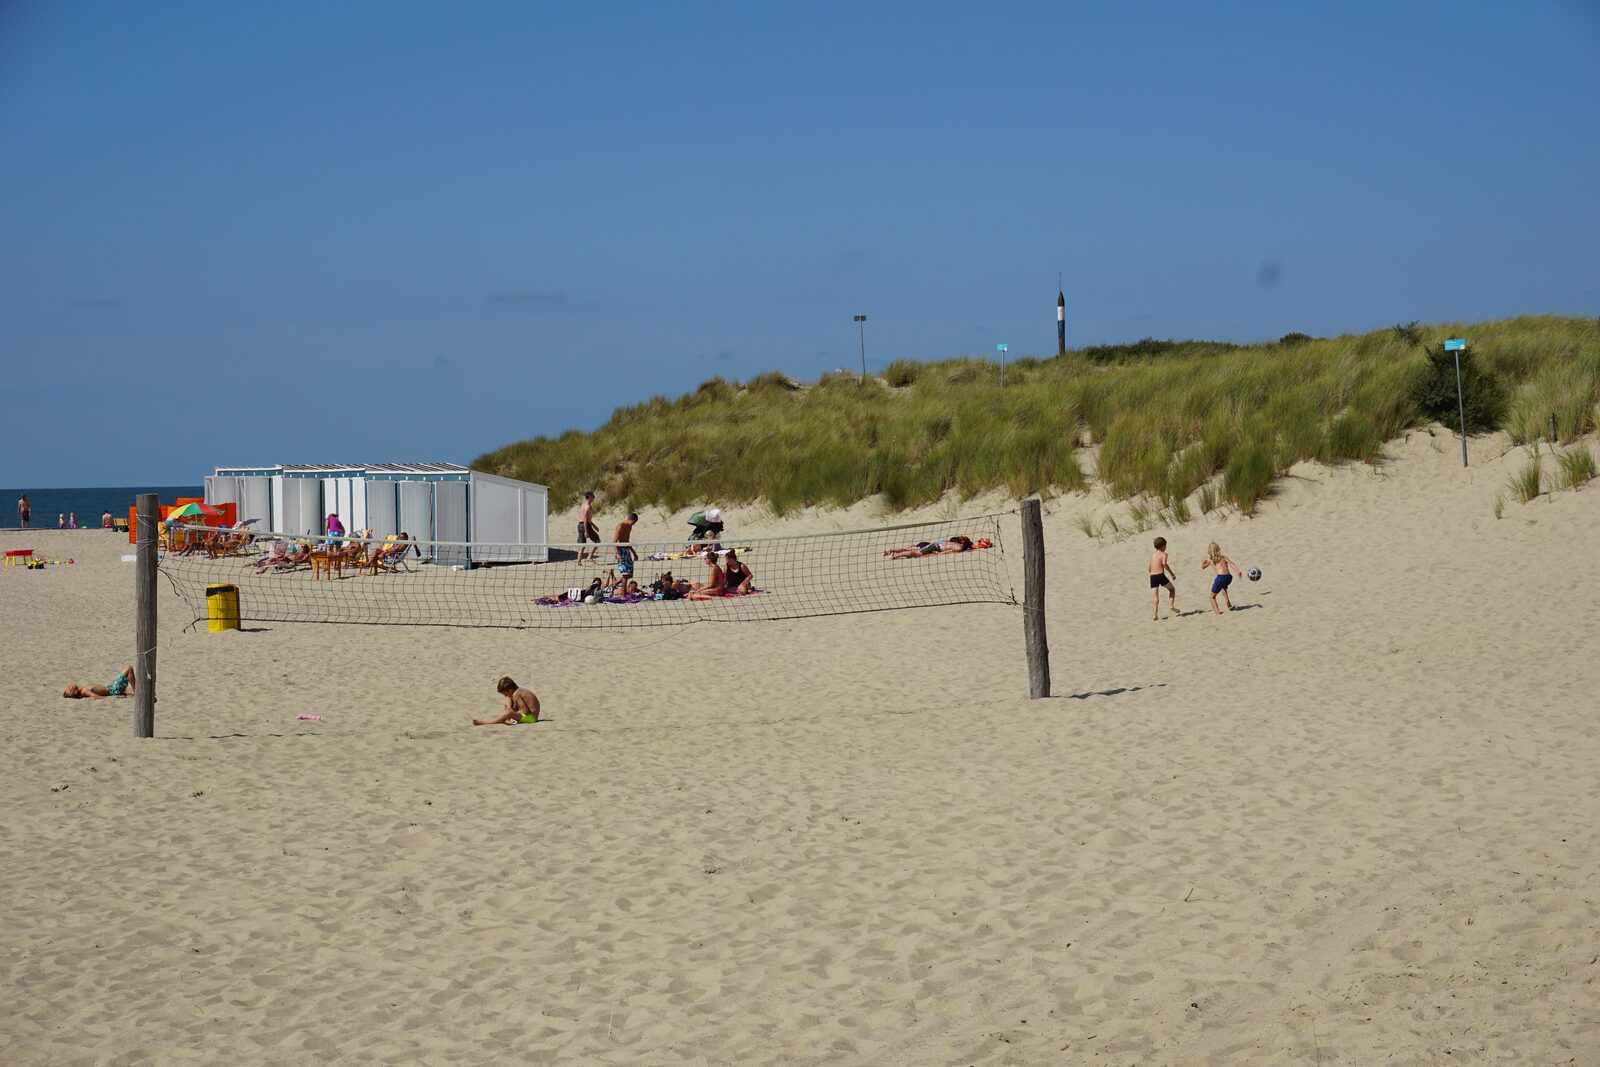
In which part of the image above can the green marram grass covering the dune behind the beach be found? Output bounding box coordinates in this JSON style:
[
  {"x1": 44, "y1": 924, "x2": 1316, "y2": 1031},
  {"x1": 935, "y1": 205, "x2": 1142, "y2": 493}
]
[{"x1": 474, "y1": 315, "x2": 1600, "y2": 517}]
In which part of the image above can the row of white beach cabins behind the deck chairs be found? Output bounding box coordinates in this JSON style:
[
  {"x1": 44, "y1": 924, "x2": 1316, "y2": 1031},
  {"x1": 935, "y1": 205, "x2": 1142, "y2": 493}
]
[{"x1": 205, "y1": 464, "x2": 550, "y2": 566}]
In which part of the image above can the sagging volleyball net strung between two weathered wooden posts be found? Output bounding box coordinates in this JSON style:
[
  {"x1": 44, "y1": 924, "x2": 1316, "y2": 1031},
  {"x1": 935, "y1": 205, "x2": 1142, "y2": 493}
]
[{"x1": 160, "y1": 515, "x2": 1016, "y2": 630}]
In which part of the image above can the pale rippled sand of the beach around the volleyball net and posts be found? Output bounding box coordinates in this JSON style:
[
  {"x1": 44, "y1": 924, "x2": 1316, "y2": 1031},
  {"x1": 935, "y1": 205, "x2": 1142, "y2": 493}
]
[{"x1": 0, "y1": 432, "x2": 1600, "y2": 1067}]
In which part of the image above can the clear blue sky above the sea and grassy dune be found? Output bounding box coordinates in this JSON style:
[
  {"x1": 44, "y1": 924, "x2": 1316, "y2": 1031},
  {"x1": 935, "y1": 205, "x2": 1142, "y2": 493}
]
[{"x1": 0, "y1": 0, "x2": 1600, "y2": 486}]
